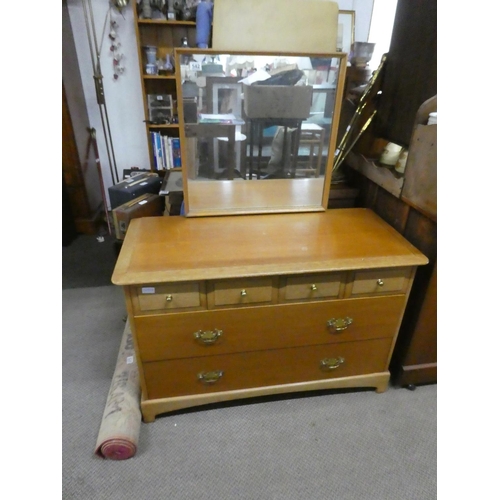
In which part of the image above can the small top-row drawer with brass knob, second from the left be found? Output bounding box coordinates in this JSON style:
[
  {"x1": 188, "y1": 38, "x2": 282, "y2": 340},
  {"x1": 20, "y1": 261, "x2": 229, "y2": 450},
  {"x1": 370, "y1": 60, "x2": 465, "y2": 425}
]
[{"x1": 209, "y1": 277, "x2": 274, "y2": 307}]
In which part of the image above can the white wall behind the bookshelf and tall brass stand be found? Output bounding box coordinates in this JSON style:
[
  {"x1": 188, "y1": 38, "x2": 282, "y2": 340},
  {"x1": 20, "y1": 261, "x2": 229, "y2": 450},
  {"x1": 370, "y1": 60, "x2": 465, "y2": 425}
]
[{"x1": 67, "y1": 0, "x2": 380, "y2": 207}]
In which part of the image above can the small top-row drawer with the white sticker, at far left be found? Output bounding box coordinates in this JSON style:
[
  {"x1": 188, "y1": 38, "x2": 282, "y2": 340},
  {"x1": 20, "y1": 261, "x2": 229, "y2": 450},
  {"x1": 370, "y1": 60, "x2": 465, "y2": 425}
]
[{"x1": 132, "y1": 282, "x2": 202, "y2": 313}]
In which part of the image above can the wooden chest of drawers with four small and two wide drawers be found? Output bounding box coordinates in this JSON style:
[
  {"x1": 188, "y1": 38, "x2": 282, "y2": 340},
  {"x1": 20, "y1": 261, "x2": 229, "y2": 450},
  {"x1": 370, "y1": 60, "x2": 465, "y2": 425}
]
[{"x1": 112, "y1": 209, "x2": 427, "y2": 422}]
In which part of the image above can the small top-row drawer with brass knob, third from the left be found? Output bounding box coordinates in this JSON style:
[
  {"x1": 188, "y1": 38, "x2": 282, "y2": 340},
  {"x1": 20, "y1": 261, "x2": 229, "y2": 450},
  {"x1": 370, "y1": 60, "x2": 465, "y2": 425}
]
[{"x1": 281, "y1": 273, "x2": 343, "y2": 302}]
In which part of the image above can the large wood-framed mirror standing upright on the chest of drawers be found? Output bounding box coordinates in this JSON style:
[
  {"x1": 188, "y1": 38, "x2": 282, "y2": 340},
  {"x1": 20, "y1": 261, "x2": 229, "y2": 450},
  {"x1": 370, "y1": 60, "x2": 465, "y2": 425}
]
[{"x1": 175, "y1": 49, "x2": 346, "y2": 216}]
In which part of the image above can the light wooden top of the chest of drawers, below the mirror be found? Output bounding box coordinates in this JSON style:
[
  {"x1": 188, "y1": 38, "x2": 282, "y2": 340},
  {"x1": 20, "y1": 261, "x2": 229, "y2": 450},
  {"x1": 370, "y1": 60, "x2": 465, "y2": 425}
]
[{"x1": 112, "y1": 208, "x2": 428, "y2": 285}]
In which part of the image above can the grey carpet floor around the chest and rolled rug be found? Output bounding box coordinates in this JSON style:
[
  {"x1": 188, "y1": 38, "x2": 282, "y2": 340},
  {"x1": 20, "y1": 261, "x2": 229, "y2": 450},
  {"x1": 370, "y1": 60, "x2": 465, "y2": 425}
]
[{"x1": 62, "y1": 286, "x2": 437, "y2": 500}]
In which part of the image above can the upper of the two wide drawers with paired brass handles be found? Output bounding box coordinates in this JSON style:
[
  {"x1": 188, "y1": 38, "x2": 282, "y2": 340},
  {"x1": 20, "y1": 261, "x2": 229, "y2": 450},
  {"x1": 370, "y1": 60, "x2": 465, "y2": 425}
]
[{"x1": 134, "y1": 295, "x2": 405, "y2": 361}]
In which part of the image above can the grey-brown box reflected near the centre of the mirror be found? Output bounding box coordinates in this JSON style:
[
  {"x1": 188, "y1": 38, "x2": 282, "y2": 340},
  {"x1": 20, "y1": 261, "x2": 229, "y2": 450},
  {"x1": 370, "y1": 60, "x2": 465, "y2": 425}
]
[{"x1": 243, "y1": 85, "x2": 313, "y2": 120}]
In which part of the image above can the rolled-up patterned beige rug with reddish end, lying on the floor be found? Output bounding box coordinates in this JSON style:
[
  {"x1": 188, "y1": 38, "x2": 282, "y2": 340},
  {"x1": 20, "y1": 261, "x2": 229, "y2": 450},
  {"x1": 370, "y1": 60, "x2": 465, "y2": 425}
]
[{"x1": 94, "y1": 319, "x2": 142, "y2": 460}]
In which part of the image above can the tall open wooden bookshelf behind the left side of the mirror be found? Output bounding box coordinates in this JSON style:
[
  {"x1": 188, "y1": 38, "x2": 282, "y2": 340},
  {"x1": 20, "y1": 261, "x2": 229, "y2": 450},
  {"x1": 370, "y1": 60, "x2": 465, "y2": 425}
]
[{"x1": 132, "y1": 0, "x2": 196, "y2": 171}]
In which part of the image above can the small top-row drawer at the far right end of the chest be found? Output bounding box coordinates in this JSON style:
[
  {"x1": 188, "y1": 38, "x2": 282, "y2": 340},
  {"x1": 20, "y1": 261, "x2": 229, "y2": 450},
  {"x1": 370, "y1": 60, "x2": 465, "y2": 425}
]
[{"x1": 351, "y1": 267, "x2": 412, "y2": 296}]
